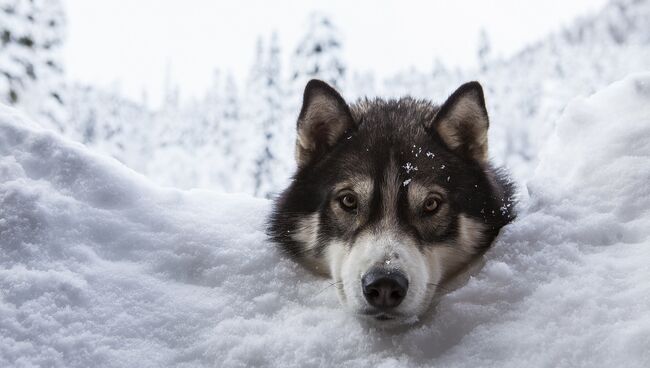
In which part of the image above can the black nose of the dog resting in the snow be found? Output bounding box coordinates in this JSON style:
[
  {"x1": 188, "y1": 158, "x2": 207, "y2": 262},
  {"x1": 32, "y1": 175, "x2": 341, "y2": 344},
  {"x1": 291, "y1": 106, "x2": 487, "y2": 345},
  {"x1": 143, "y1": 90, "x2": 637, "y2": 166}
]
[{"x1": 361, "y1": 270, "x2": 409, "y2": 309}]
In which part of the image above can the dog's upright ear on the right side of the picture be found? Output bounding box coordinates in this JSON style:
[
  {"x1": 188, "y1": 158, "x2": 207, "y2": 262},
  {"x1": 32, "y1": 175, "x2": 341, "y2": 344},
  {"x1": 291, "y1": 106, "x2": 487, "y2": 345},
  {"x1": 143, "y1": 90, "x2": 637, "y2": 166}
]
[{"x1": 431, "y1": 82, "x2": 489, "y2": 162}]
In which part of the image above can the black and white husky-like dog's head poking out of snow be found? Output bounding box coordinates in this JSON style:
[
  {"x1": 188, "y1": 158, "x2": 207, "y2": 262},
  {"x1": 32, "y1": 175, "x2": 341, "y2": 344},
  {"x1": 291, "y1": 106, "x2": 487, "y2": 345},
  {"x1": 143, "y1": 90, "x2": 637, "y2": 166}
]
[{"x1": 268, "y1": 80, "x2": 515, "y2": 326}]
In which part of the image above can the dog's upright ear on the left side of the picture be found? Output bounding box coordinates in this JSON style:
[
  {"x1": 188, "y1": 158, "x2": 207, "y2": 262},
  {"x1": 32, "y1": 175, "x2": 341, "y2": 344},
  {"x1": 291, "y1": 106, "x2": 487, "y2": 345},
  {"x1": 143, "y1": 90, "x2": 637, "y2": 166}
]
[{"x1": 296, "y1": 79, "x2": 354, "y2": 167}]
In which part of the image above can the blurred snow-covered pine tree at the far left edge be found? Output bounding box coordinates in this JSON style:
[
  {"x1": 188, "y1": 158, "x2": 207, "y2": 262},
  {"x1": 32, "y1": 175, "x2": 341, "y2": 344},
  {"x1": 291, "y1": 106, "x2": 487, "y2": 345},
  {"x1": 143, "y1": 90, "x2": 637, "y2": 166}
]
[{"x1": 0, "y1": 0, "x2": 66, "y2": 131}]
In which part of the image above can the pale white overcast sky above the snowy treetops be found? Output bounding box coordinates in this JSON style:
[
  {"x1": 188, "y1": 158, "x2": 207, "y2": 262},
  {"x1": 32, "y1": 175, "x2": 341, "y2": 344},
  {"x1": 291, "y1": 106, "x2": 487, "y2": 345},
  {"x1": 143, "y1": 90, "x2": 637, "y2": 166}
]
[{"x1": 64, "y1": 0, "x2": 606, "y2": 106}]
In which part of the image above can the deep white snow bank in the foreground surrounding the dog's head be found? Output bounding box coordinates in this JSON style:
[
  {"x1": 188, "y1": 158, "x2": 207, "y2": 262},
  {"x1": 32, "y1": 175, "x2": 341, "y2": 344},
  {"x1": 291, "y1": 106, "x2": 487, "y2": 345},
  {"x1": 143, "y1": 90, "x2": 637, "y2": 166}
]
[{"x1": 0, "y1": 74, "x2": 650, "y2": 367}]
